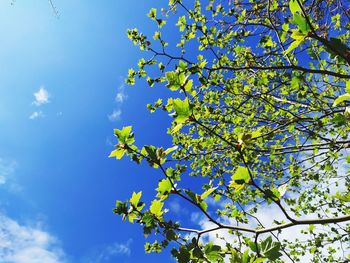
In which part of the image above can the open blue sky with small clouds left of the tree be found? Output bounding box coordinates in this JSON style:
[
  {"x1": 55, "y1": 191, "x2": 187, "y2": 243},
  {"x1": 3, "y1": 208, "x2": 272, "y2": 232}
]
[{"x1": 0, "y1": 0, "x2": 178, "y2": 263}]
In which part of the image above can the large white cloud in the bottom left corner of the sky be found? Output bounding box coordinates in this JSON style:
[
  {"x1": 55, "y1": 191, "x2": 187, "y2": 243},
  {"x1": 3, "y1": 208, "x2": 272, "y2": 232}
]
[{"x1": 0, "y1": 214, "x2": 66, "y2": 263}]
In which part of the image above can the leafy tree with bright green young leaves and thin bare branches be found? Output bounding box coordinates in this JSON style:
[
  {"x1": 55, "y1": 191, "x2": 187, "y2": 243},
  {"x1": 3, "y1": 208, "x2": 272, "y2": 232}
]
[{"x1": 110, "y1": 0, "x2": 350, "y2": 263}]
